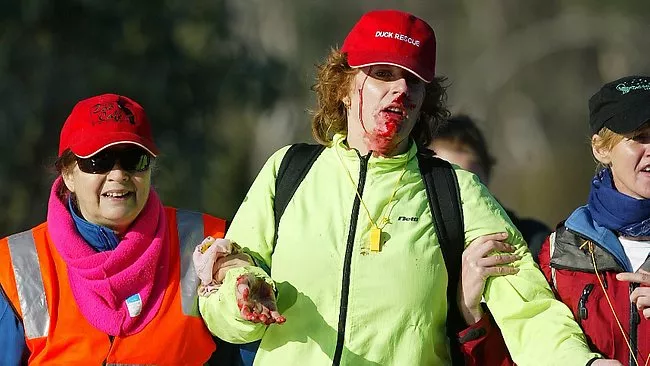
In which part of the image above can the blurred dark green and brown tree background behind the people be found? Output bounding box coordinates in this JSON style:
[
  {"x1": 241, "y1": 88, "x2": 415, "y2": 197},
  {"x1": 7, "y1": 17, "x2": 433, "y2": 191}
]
[{"x1": 0, "y1": 0, "x2": 650, "y2": 236}]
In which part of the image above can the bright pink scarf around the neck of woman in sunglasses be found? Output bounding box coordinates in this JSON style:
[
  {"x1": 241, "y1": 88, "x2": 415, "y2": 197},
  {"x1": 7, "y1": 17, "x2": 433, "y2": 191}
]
[{"x1": 47, "y1": 177, "x2": 170, "y2": 336}]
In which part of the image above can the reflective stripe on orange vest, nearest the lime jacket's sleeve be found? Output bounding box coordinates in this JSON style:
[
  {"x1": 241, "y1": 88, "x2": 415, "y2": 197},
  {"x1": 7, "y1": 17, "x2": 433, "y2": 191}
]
[{"x1": 176, "y1": 210, "x2": 205, "y2": 317}]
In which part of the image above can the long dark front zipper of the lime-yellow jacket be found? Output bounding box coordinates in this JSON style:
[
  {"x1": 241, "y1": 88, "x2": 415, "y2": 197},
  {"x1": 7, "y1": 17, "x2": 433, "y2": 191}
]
[{"x1": 332, "y1": 152, "x2": 371, "y2": 366}]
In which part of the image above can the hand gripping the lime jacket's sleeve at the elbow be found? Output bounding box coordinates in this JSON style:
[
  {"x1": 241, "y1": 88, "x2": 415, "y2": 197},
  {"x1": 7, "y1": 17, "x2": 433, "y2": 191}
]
[{"x1": 458, "y1": 233, "x2": 521, "y2": 325}]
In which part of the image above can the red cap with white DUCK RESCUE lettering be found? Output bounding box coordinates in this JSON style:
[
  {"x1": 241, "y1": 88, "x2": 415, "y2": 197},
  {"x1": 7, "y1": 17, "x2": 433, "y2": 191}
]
[{"x1": 341, "y1": 10, "x2": 436, "y2": 83}]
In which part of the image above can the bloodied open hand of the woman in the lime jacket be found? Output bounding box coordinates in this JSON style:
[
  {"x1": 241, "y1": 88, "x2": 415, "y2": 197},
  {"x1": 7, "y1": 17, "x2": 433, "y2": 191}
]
[{"x1": 236, "y1": 274, "x2": 286, "y2": 325}]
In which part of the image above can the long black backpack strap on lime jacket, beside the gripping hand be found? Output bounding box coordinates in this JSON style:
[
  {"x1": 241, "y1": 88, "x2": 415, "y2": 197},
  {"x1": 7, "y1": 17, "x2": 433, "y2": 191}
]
[{"x1": 418, "y1": 151, "x2": 465, "y2": 365}]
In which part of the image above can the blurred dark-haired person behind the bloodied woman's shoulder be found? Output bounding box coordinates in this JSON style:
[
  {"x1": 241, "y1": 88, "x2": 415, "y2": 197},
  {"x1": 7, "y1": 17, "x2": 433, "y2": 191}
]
[{"x1": 429, "y1": 115, "x2": 551, "y2": 260}]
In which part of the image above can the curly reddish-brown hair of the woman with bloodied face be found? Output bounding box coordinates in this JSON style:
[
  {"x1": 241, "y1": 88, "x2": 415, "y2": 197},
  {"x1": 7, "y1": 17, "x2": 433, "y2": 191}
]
[{"x1": 311, "y1": 48, "x2": 450, "y2": 147}]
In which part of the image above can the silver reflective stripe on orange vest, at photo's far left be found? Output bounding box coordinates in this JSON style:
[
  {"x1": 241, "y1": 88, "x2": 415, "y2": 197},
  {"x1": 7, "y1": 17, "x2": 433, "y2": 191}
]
[{"x1": 7, "y1": 230, "x2": 50, "y2": 339}]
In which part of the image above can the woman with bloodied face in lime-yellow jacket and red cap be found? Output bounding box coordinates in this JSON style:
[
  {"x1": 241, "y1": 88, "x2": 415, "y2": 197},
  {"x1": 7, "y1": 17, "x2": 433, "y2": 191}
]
[{"x1": 199, "y1": 10, "x2": 603, "y2": 365}]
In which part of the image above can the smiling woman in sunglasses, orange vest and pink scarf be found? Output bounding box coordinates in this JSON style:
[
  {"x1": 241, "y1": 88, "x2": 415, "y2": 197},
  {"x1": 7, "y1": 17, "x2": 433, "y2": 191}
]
[{"x1": 0, "y1": 94, "x2": 275, "y2": 365}]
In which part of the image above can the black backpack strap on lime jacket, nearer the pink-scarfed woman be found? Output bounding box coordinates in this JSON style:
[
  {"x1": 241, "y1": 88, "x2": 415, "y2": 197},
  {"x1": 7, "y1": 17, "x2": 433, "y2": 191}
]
[{"x1": 273, "y1": 143, "x2": 325, "y2": 241}]
